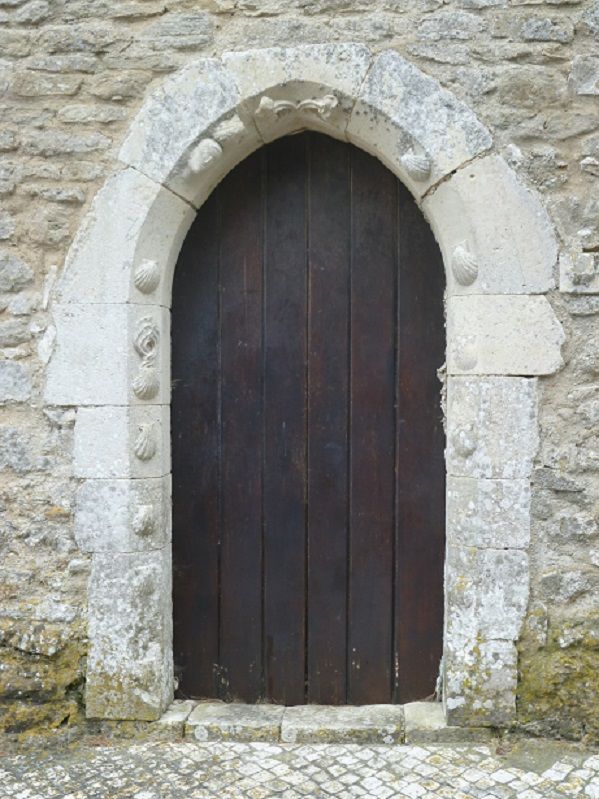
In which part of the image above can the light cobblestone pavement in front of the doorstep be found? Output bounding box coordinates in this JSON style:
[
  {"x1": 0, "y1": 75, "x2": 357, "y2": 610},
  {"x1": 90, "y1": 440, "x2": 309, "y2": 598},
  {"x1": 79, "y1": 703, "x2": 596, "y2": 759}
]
[{"x1": 0, "y1": 742, "x2": 599, "y2": 799}]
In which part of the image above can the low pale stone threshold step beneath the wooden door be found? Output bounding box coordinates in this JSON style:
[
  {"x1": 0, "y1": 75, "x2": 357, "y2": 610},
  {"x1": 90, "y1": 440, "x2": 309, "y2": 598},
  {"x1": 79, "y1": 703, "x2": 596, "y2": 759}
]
[{"x1": 158, "y1": 700, "x2": 494, "y2": 745}]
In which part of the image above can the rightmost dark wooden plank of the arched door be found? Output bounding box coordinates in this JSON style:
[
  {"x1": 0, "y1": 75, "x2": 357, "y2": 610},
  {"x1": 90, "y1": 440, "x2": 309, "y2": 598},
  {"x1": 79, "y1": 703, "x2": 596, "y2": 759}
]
[{"x1": 395, "y1": 187, "x2": 445, "y2": 702}]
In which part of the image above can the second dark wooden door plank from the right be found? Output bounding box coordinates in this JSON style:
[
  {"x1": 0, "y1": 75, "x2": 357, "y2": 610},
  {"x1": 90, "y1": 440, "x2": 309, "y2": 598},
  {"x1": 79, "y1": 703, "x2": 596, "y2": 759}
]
[{"x1": 348, "y1": 150, "x2": 397, "y2": 704}]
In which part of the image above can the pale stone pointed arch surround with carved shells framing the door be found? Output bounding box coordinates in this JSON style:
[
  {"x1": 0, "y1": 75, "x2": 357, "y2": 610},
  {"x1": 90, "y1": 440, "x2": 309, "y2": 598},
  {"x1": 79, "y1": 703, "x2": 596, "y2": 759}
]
[{"x1": 45, "y1": 44, "x2": 563, "y2": 725}]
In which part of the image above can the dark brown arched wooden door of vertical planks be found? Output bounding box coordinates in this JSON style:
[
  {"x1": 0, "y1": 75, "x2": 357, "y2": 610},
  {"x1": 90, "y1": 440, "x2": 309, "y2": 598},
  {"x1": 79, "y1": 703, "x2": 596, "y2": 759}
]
[{"x1": 172, "y1": 133, "x2": 445, "y2": 705}]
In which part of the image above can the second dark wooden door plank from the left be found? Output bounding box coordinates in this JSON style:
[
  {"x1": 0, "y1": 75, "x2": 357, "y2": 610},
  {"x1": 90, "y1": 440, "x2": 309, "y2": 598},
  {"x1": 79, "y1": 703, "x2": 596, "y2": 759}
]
[{"x1": 220, "y1": 153, "x2": 263, "y2": 702}]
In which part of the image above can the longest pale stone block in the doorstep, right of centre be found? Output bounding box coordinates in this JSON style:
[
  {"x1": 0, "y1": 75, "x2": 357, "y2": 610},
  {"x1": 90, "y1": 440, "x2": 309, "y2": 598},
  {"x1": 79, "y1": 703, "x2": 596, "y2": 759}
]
[{"x1": 281, "y1": 705, "x2": 403, "y2": 744}]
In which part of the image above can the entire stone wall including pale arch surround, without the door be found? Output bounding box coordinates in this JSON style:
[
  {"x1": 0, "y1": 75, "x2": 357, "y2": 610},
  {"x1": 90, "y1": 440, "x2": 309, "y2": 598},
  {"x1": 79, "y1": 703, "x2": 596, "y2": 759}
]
[{"x1": 0, "y1": 0, "x2": 599, "y2": 742}]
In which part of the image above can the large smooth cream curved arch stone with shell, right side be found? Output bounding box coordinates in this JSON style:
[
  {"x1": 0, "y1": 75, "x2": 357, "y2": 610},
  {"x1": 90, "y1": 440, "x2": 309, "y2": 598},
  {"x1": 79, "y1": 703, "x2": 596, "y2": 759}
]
[{"x1": 423, "y1": 156, "x2": 557, "y2": 295}]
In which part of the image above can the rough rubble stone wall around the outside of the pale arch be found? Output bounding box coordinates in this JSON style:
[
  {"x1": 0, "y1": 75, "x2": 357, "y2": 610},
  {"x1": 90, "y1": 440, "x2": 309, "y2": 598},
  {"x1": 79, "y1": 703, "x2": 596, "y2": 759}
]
[{"x1": 0, "y1": 0, "x2": 599, "y2": 738}]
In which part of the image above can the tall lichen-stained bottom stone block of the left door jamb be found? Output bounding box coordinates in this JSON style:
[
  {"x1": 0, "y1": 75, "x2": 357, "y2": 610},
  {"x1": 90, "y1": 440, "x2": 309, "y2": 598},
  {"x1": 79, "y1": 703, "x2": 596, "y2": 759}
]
[{"x1": 86, "y1": 547, "x2": 173, "y2": 721}]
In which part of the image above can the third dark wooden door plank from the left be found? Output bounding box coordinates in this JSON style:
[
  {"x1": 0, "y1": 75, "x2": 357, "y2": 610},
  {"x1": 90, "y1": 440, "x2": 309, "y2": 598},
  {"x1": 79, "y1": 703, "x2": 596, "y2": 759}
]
[{"x1": 264, "y1": 136, "x2": 306, "y2": 705}]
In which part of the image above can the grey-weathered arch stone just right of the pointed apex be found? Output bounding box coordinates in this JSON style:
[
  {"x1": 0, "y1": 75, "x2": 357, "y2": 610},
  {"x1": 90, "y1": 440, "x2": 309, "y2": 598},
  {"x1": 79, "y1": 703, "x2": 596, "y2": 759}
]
[{"x1": 347, "y1": 50, "x2": 491, "y2": 197}]
